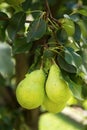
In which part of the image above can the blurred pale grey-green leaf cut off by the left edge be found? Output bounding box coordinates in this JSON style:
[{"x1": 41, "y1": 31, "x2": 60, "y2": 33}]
[{"x1": 0, "y1": 43, "x2": 14, "y2": 77}]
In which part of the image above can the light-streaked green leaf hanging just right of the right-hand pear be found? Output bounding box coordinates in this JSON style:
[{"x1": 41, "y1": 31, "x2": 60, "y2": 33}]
[{"x1": 65, "y1": 76, "x2": 83, "y2": 100}]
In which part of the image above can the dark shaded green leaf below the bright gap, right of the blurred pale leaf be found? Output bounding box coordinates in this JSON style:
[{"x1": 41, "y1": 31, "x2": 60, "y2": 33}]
[{"x1": 12, "y1": 37, "x2": 32, "y2": 54}]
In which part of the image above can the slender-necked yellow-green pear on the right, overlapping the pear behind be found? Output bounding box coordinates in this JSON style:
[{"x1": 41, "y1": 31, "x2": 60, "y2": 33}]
[{"x1": 46, "y1": 64, "x2": 71, "y2": 104}]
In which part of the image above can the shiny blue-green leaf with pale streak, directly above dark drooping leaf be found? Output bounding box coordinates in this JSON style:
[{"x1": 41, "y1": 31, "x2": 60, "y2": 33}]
[{"x1": 65, "y1": 47, "x2": 82, "y2": 69}]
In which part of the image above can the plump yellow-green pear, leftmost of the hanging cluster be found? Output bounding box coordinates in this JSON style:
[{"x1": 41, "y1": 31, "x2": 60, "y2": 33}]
[{"x1": 16, "y1": 69, "x2": 45, "y2": 109}]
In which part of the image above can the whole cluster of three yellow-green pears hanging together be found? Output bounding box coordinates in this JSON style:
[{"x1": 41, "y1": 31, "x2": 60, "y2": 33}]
[{"x1": 16, "y1": 64, "x2": 71, "y2": 113}]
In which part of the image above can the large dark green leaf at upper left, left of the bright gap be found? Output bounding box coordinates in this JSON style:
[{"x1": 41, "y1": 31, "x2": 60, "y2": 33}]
[{"x1": 7, "y1": 12, "x2": 26, "y2": 40}]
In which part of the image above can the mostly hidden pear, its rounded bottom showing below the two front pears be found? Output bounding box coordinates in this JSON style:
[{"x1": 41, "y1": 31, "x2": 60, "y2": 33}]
[{"x1": 43, "y1": 96, "x2": 66, "y2": 113}]
